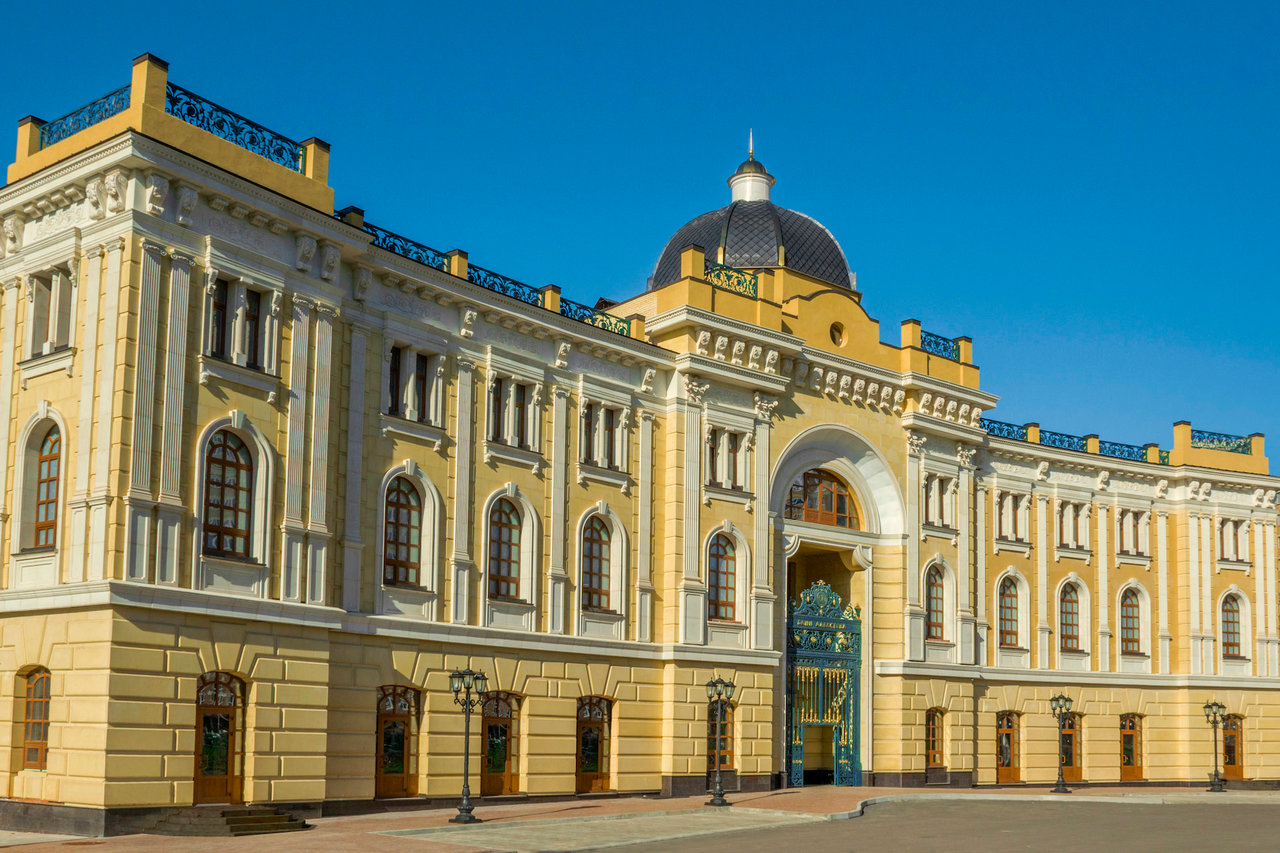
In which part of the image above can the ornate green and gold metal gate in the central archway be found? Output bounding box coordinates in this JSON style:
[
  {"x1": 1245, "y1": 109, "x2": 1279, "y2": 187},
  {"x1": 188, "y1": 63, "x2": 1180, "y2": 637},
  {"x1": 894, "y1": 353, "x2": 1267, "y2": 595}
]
[{"x1": 787, "y1": 580, "x2": 863, "y2": 786}]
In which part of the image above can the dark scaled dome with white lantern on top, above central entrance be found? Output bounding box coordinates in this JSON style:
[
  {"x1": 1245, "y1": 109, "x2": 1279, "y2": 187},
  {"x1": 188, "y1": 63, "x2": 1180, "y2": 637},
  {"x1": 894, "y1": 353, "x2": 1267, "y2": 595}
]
[{"x1": 649, "y1": 156, "x2": 852, "y2": 291}]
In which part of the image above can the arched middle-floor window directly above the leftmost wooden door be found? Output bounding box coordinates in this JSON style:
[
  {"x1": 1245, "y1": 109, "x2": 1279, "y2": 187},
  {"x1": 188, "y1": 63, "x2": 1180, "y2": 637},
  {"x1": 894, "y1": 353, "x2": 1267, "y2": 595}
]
[{"x1": 204, "y1": 429, "x2": 253, "y2": 560}]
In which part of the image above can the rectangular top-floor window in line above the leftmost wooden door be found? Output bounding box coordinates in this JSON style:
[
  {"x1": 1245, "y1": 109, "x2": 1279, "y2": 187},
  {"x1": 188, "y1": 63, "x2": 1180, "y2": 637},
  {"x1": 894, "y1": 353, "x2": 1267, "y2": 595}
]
[{"x1": 204, "y1": 278, "x2": 283, "y2": 375}]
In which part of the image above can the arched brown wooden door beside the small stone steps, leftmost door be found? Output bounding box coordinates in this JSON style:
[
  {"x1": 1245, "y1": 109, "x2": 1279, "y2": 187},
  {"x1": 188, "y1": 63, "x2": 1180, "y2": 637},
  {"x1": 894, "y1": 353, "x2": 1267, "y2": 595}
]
[{"x1": 193, "y1": 672, "x2": 244, "y2": 806}]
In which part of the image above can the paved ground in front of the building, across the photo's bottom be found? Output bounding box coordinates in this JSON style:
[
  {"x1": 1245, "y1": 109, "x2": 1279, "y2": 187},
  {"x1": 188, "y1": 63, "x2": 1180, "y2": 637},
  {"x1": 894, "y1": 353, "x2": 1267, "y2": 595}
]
[{"x1": 12, "y1": 786, "x2": 1280, "y2": 853}]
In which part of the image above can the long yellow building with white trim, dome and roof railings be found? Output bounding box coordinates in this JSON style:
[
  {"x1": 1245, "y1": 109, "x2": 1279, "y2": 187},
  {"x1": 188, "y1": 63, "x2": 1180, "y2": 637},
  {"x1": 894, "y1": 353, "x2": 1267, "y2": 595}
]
[{"x1": 0, "y1": 55, "x2": 1280, "y2": 833}]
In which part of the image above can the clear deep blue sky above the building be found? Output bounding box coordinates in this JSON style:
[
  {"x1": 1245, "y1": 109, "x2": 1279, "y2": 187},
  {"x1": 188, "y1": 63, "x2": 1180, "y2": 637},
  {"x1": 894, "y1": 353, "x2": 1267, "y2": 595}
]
[{"x1": 10, "y1": 1, "x2": 1280, "y2": 455}]
